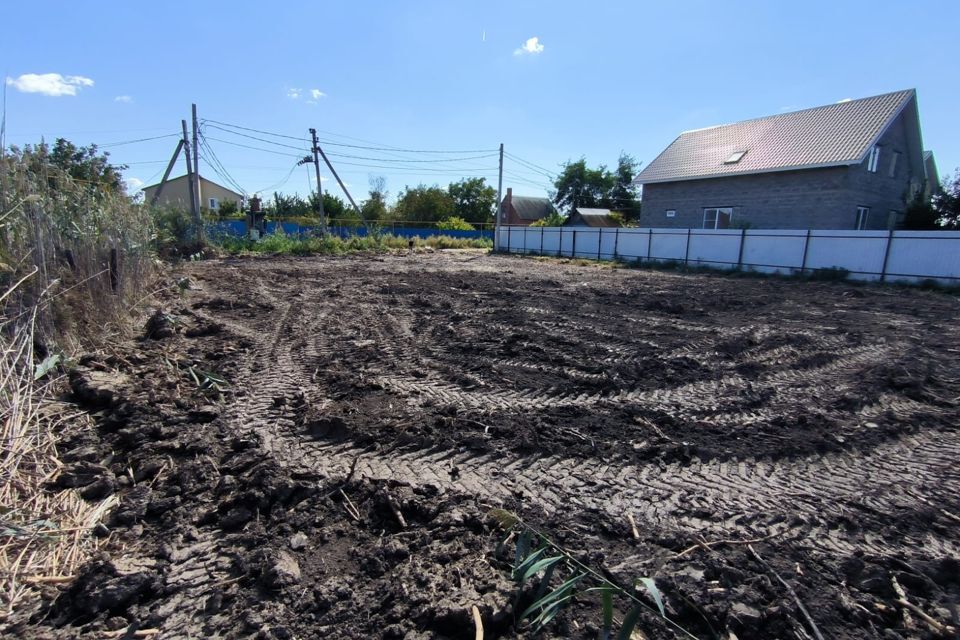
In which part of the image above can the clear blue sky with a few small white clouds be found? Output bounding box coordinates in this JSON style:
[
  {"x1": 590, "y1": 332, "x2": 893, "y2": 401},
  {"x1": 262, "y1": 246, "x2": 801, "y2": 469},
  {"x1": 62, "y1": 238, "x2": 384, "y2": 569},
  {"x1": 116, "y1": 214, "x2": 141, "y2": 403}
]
[{"x1": 0, "y1": 0, "x2": 960, "y2": 201}]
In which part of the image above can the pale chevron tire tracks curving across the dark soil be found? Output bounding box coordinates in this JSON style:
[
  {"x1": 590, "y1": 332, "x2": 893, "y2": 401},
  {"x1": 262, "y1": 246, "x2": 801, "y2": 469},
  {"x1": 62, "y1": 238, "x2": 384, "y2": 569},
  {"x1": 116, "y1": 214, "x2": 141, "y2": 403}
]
[{"x1": 172, "y1": 254, "x2": 960, "y2": 624}]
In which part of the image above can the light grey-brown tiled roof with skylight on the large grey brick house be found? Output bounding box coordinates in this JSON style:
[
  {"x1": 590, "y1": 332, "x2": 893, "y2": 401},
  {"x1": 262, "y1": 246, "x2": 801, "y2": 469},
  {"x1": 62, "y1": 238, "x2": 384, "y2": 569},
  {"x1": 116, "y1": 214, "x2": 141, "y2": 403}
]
[{"x1": 635, "y1": 89, "x2": 915, "y2": 184}]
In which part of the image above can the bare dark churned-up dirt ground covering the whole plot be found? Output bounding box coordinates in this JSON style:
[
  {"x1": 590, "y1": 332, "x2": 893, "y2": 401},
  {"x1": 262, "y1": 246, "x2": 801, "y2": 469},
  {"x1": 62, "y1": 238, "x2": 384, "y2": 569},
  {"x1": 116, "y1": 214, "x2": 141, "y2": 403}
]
[{"x1": 15, "y1": 252, "x2": 960, "y2": 639}]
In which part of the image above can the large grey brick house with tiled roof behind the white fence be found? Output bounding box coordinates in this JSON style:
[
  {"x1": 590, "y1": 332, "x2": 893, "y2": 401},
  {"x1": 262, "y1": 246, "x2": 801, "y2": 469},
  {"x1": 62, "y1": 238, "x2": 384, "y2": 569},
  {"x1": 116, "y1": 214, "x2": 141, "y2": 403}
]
[{"x1": 634, "y1": 89, "x2": 938, "y2": 229}]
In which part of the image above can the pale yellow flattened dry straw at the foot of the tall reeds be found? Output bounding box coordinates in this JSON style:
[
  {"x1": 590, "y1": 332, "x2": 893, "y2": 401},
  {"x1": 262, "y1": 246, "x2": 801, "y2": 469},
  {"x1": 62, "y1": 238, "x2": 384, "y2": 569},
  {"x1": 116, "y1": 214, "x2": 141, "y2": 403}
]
[{"x1": 0, "y1": 294, "x2": 116, "y2": 624}]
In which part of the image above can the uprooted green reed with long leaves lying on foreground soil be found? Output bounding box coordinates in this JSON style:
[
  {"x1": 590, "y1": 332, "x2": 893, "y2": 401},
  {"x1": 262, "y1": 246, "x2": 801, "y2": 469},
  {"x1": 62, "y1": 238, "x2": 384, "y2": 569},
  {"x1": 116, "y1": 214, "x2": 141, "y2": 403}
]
[{"x1": 489, "y1": 509, "x2": 695, "y2": 640}]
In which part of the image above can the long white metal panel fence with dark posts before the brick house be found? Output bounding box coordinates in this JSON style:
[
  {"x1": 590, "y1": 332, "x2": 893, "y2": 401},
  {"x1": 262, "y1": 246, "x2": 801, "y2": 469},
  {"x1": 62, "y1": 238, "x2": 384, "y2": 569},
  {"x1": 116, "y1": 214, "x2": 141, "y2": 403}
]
[{"x1": 497, "y1": 226, "x2": 960, "y2": 284}]
